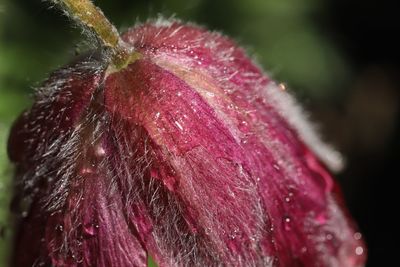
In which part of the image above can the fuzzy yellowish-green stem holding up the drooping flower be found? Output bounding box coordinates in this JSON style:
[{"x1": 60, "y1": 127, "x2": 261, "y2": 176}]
[{"x1": 53, "y1": 0, "x2": 139, "y2": 69}]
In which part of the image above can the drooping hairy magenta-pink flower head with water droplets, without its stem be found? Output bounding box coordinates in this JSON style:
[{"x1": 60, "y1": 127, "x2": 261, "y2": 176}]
[{"x1": 9, "y1": 20, "x2": 365, "y2": 267}]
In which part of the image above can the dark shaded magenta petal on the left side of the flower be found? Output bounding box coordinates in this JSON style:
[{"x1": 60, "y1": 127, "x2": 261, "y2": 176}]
[{"x1": 9, "y1": 59, "x2": 147, "y2": 267}]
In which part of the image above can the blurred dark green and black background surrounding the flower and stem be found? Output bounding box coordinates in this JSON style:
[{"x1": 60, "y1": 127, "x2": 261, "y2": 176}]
[{"x1": 0, "y1": 0, "x2": 400, "y2": 266}]
